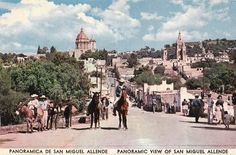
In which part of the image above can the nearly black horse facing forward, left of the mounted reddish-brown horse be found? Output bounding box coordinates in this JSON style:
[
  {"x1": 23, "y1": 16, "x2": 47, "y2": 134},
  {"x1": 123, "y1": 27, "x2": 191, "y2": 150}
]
[{"x1": 87, "y1": 92, "x2": 101, "y2": 128}]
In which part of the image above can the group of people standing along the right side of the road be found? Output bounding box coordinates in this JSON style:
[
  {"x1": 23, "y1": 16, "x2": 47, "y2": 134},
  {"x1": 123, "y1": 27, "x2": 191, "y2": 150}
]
[{"x1": 182, "y1": 90, "x2": 236, "y2": 128}]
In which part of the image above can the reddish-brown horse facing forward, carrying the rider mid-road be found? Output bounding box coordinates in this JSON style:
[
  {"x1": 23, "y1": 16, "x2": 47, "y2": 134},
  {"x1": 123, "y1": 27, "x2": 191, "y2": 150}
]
[{"x1": 117, "y1": 89, "x2": 129, "y2": 129}]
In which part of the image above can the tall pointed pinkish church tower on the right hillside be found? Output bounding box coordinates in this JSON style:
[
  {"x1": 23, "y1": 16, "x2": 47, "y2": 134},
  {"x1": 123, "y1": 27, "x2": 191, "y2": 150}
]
[{"x1": 176, "y1": 32, "x2": 187, "y2": 62}]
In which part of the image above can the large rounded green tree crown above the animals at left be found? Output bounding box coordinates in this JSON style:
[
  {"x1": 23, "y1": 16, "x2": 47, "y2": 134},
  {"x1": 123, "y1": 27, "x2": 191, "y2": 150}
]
[{"x1": 11, "y1": 60, "x2": 89, "y2": 99}]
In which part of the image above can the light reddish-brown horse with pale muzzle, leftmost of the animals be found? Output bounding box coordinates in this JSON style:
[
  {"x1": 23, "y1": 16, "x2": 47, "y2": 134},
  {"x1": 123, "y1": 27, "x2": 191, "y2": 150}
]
[{"x1": 16, "y1": 103, "x2": 43, "y2": 133}]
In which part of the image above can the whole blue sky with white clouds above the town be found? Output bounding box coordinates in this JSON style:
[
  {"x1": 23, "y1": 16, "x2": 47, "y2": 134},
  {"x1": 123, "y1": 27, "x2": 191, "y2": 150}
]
[{"x1": 0, "y1": 0, "x2": 236, "y2": 53}]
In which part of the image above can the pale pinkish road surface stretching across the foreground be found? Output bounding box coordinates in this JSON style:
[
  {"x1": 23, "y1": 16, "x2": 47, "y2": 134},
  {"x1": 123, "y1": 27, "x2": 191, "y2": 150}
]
[{"x1": 0, "y1": 107, "x2": 236, "y2": 149}]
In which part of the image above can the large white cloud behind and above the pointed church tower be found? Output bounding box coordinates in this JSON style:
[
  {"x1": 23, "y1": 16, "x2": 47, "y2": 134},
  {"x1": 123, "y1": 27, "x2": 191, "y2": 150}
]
[{"x1": 143, "y1": 0, "x2": 229, "y2": 41}]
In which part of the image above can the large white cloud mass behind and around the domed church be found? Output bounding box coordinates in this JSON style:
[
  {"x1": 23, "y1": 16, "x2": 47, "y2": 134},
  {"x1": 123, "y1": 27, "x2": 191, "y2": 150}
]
[{"x1": 0, "y1": 0, "x2": 140, "y2": 52}]
